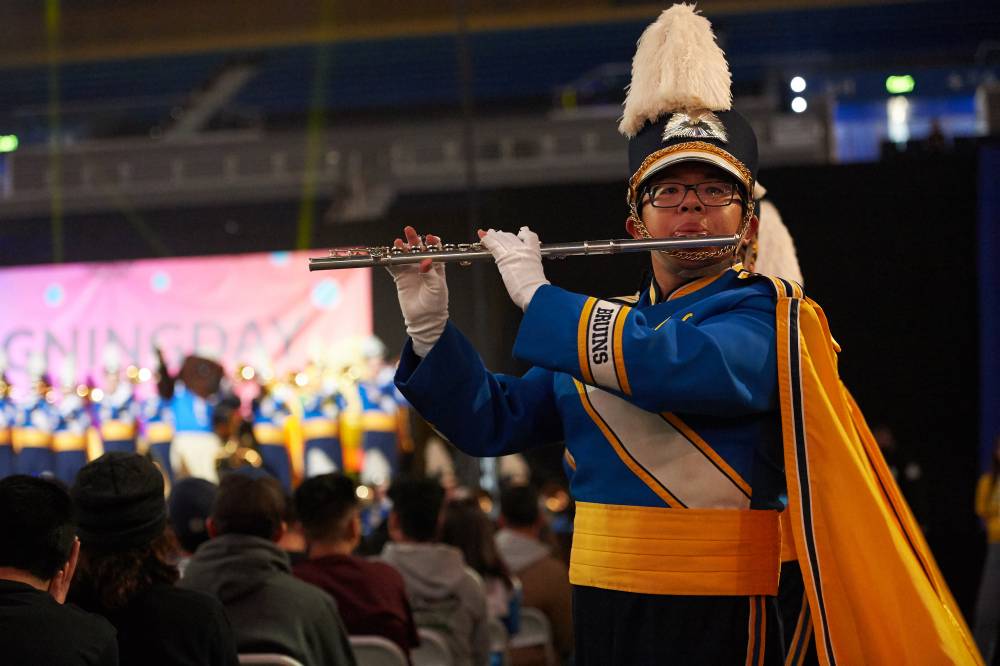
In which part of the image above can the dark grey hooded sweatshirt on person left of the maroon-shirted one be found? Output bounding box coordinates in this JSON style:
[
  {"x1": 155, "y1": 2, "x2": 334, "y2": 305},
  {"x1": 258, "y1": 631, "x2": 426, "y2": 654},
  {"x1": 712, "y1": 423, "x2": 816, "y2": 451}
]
[{"x1": 178, "y1": 534, "x2": 355, "y2": 666}]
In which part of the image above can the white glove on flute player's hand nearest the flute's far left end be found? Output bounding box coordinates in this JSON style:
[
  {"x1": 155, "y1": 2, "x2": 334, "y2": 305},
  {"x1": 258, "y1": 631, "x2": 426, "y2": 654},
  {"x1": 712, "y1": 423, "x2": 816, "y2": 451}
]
[{"x1": 386, "y1": 254, "x2": 448, "y2": 358}]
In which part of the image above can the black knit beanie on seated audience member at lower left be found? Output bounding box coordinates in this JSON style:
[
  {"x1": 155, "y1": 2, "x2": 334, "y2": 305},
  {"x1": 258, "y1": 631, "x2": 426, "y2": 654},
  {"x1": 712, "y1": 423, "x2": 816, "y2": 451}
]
[{"x1": 70, "y1": 451, "x2": 167, "y2": 551}]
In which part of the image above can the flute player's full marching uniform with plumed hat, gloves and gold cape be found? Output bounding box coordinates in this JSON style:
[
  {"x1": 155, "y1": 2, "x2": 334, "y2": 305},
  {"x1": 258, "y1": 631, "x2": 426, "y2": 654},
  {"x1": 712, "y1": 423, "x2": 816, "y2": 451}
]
[{"x1": 390, "y1": 5, "x2": 981, "y2": 666}]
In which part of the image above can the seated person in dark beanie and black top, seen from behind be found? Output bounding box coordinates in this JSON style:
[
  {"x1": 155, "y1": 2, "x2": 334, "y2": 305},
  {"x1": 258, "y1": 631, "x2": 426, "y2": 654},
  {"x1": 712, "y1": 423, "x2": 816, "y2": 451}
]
[{"x1": 70, "y1": 452, "x2": 238, "y2": 665}]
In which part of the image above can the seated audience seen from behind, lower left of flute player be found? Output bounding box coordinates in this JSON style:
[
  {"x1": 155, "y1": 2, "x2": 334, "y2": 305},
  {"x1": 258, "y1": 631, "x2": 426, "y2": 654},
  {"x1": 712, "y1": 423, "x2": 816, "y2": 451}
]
[{"x1": 0, "y1": 452, "x2": 573, "y2": 666}]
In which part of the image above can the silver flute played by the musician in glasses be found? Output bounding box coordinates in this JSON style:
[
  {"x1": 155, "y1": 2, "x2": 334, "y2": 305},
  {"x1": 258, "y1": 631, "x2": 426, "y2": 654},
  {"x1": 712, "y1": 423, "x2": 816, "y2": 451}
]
[{"x1": 309, "y1": 235, "x2": 740, "y2": 271}]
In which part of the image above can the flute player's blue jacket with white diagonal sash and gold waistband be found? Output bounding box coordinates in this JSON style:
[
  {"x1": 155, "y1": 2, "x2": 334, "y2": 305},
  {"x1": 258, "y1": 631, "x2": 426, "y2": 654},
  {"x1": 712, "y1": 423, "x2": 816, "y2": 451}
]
[{"x1": 396, "y1": 267, "x2": 784, "y2": 595}]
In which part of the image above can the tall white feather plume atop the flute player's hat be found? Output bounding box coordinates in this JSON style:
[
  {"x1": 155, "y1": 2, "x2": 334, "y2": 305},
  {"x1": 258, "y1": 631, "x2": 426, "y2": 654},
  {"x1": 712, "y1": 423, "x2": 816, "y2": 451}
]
[{"x1": 618, "y1": 4, "x2": 733, "y2": 138}]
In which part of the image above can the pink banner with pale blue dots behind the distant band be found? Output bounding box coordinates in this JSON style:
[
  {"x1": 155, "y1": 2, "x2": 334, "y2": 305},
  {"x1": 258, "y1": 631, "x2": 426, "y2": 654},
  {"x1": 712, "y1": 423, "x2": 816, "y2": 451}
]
[{"x1": 0, "y1": 251, "x2": 372, "y2": 386}]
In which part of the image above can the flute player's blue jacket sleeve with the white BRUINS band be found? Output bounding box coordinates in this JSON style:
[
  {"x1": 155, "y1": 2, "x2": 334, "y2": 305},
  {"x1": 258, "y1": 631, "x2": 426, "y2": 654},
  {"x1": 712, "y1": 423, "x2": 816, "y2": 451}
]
[{"x1": 514, "y1": 285, "x2": 777, "y2": 416}]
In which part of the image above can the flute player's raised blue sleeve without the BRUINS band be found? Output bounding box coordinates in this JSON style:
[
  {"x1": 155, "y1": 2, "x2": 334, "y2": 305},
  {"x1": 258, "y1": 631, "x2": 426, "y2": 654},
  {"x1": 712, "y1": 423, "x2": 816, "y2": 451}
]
[{"x1": 396, "y1": 323, "x2": 562, "y2": 456}]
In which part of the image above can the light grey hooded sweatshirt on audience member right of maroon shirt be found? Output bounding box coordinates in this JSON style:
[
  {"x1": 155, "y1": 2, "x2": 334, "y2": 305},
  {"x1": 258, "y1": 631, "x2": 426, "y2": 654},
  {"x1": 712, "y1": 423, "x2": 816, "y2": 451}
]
[{"x1": 382, "y1": 543, "x2": 490, "y2": 666}]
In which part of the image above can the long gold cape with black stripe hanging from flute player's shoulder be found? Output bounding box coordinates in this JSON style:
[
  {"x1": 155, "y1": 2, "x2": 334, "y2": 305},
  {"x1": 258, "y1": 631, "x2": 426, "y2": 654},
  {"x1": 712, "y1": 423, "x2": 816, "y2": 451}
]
[{"x1": 772, "y1": 278, "x2": 983, "y2": 665}]
